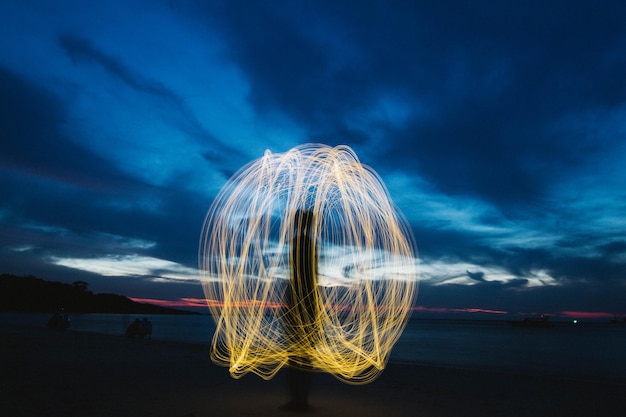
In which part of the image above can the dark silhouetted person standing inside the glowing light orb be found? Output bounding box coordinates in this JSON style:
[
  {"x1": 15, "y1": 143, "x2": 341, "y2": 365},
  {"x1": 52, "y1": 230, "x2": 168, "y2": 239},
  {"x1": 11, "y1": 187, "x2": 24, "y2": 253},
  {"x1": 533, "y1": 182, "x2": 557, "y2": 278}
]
[{"x1": 282, "y1": 210, "x2": 320, "y2": 411}]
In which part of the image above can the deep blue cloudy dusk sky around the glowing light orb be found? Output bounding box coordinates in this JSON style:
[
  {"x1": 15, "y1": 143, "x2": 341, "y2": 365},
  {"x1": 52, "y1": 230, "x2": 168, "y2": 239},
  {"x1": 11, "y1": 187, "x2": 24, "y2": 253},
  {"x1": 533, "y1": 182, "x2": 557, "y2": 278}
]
[{"x1": 0, "y1": 0, "x2": 626, "y2": 319}]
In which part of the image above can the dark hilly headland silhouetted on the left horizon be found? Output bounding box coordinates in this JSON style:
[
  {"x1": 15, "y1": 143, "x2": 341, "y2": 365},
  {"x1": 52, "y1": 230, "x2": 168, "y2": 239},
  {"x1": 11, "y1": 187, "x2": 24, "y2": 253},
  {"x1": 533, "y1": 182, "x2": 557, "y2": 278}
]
[{"x1": 0, "y1": 274, "x2": 199, "y2": 314}]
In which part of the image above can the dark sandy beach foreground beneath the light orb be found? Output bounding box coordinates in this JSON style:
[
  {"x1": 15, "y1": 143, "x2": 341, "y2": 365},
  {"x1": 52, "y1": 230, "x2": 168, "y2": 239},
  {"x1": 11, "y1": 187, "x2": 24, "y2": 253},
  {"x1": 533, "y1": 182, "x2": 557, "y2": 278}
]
[{"x1": 0, "y1": 324, "x2": 626, "y2": 417}]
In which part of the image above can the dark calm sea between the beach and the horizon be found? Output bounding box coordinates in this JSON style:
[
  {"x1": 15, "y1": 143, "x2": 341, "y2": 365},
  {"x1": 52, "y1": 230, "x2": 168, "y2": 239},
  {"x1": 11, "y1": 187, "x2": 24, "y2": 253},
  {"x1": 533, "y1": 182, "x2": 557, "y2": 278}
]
[{"x1": 0, "y1": 313, "x2": 626, "y2": 384}]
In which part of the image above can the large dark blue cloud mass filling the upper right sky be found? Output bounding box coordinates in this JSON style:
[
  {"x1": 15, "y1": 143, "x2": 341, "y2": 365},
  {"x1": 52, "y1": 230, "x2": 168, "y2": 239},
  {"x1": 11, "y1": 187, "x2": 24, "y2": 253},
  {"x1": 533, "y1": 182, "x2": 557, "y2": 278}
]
[{"x1": 188, "y1": 2, "x2": 626, "y2": 210}]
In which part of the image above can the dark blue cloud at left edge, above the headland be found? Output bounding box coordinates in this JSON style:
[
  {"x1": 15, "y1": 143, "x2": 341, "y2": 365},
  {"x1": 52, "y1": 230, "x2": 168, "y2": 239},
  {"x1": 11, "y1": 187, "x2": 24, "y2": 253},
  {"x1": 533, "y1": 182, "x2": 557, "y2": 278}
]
[{"x1": 0, "y1": 68, "x2": 137, "y2": 192}]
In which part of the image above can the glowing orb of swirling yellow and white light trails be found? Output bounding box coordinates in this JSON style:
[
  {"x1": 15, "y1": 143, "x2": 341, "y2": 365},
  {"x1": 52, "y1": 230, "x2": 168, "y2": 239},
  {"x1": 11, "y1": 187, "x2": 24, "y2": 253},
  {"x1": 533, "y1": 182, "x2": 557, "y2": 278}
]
[{"x1": 199, "y1": 144, "x2": 417, "y2": 384}]
